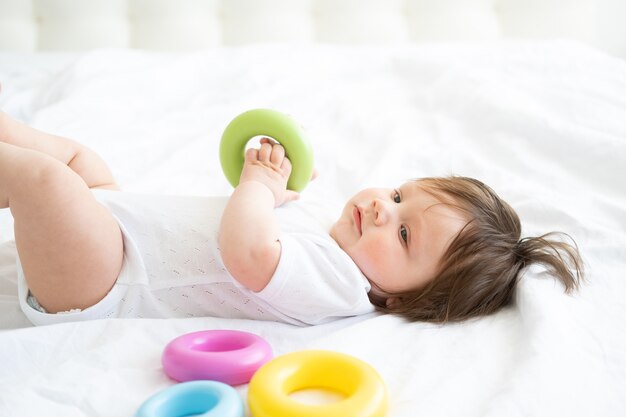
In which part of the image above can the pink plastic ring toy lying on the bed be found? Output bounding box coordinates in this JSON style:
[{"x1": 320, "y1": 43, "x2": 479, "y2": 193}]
[{"x1": 162, "y1": 330, "x2": 272, "y2": 385}]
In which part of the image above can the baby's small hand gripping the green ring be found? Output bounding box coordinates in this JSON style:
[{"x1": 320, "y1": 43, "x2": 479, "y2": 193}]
[{"x1": 239, "y1": 138, "x2": 300, "y2": 207}]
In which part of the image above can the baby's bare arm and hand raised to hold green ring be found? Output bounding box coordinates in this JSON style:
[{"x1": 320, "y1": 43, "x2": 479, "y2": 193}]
[{"x1": 219, "y1": 139, "x2": 298, "y2": 292}]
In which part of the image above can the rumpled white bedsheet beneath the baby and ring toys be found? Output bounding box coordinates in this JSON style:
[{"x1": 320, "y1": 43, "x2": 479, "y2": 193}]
[{"x1": 0, "y1": 43, "x2": 626, "y2": 417}]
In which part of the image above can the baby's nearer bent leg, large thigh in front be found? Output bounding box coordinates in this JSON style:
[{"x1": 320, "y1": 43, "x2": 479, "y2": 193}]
[{"x1": 0, "y1": 142, "x2": 123, "y2": 312}]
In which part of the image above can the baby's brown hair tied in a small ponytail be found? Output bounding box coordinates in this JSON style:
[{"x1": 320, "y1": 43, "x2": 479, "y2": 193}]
[{"x1": 371, "y1": 176, "x2": 583, "y2": 323}]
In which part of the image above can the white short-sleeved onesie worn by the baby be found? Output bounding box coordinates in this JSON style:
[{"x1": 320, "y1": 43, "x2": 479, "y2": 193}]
[{"x1": 18, "y1": 190, "x2": 374, "y2": 325}]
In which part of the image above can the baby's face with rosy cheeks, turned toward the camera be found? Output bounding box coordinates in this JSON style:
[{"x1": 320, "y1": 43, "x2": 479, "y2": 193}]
[{"x1": 330, "y1": 181, "x2": 467, "y2": 304}]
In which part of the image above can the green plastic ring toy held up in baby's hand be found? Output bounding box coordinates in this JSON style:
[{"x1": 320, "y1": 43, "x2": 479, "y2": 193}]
[{"x1": 220, "y1": 109, "x2": 313, "y2": 191}]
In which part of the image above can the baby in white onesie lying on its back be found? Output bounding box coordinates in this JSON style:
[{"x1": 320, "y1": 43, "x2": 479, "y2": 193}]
[{"x1": 0, "y1": 112, "x2": 582, "y2": 325}]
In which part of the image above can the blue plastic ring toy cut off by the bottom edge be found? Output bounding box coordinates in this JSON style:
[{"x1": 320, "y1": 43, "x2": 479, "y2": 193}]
[{"x1": 135, "y1": 381, "x2": 243, "y2": 417}]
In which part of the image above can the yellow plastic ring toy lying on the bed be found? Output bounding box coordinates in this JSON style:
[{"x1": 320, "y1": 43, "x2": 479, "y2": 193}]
[{"x1": 248, "y1": 350, "x2": 387, "y2": 417}]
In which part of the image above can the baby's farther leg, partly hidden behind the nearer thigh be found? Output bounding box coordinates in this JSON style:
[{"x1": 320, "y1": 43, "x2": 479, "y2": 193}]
[{"x1": 0, "y1": 111, "x2": 119, "y2": 190}]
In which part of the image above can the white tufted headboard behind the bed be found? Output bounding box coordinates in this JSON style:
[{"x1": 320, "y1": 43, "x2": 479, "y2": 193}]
[{"x1": 0, "y1": 0, "x2": 626, "y2": 56}]
